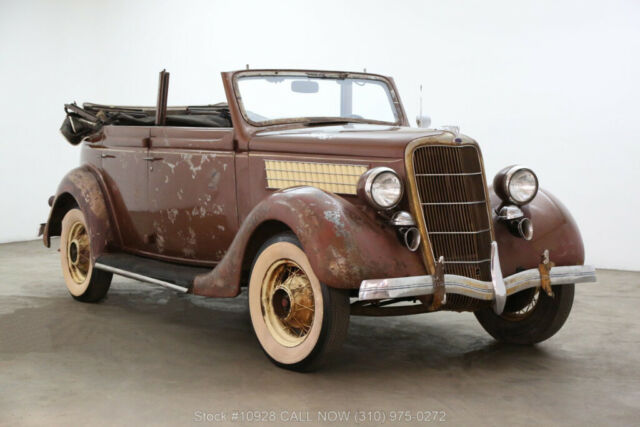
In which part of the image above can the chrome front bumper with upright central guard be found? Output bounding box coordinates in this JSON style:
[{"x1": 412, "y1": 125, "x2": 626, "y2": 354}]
[{"x1": 359, "y1": 242, "x2": 596, "y2": 314}]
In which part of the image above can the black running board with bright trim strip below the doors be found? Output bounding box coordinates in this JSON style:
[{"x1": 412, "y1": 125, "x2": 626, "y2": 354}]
[{"x1": 94, "y1": 253, "x2": 211, "y2": 293}]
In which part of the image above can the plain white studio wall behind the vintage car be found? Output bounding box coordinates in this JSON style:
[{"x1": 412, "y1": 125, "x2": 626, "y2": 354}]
[{"x1": 0, "y1": 0, "x2": 640, "y2": 270}]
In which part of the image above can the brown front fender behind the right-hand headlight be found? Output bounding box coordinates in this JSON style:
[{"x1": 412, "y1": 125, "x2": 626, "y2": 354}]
[{"x1": 490, "y1": 189, "x2": 584, "y2": 276}]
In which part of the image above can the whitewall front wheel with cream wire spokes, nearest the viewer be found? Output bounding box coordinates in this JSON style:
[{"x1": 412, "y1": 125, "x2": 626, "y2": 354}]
[{"x1": 249, "y1": 233, "x2": 350, "y2": 371}]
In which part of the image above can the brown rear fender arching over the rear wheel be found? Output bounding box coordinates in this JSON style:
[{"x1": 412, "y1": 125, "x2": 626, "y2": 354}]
[{"x1": 43, "y1": 165, "x2": 113, "y2": 262}]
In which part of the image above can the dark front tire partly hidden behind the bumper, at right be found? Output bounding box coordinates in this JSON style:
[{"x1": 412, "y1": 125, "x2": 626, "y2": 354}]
[{"x1": 474, "y1": 284, "x2": 575, "y2": 345}]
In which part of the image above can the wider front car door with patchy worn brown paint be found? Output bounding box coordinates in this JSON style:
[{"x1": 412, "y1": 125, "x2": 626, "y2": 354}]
[{"x1": 148, "y1": 127, "x2": 238, "y2": 265}]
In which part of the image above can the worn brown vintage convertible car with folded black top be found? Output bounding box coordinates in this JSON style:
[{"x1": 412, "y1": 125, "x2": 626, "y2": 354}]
[{"x1": 40, "y1": 69, "x2": 595, "y2": 371}]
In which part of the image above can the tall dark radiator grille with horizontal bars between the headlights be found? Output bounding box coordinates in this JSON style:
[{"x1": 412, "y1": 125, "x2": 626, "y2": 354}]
[{"x1": 413, "y1": 145, "x2": 491, "y2": 280}]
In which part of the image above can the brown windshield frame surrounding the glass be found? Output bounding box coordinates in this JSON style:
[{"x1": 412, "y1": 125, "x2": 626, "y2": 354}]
[{"x1": 232, "y1": 70, "x2": 406, "y2": 128}]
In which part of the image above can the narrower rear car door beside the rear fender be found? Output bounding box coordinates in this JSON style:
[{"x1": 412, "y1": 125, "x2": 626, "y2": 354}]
[{"x1": 96, "y1": 126, "x2": 152, "y2": 252}]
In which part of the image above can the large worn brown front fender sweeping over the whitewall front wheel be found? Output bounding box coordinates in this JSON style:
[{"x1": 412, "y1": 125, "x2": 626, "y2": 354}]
[{"x1": 193, "y1": 187, "x2": 426, "y2": 297}]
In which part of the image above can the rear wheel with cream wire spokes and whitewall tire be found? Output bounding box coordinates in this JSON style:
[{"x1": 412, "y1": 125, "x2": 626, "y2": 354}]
[{"x1": 60, "y1": 209, "x2": 112, "y2": 302}]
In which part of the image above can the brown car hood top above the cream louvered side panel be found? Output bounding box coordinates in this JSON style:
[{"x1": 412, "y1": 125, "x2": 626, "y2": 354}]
[{"x1": 249, "y1": 124, "x2": 453, "y2": 158}]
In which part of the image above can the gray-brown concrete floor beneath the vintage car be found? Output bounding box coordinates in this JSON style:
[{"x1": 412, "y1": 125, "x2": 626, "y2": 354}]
[{"x1": 0, "y1": 241, "x2": 640, "y2": 426}]
